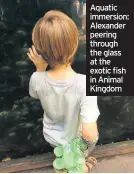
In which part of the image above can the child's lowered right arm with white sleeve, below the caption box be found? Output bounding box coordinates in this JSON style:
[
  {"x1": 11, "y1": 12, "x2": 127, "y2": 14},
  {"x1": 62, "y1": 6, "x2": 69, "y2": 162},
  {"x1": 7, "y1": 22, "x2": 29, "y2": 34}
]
[{"x1": 80, "y1": 94, "x2": 100, "y2": 155}]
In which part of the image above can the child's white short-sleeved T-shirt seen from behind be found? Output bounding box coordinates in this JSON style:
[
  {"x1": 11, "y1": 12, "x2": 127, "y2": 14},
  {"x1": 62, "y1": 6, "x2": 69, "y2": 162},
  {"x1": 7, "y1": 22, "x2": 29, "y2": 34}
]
[{"x1": 29, "y1": 71, "x2": 100, "y2": 146}]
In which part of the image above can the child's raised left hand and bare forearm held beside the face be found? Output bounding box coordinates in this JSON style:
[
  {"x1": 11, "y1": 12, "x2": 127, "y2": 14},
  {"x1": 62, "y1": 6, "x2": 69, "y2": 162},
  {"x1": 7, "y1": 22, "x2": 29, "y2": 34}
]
[{"x1": 27, "y1": 46, "x2": 48, "y2": 71}]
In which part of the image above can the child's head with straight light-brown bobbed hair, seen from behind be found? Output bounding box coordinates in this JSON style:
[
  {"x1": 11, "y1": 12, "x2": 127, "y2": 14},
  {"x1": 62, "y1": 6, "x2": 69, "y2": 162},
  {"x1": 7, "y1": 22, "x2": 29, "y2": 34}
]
[{"x1": 32, "y1": 10, "x2": 78, "y2": 68}]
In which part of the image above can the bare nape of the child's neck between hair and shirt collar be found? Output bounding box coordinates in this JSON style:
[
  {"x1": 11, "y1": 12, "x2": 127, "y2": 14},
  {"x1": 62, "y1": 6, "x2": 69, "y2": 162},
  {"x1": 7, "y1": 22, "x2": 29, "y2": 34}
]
[{"x1": 48, "y1": 66, "x2": 76, "y2": 81}]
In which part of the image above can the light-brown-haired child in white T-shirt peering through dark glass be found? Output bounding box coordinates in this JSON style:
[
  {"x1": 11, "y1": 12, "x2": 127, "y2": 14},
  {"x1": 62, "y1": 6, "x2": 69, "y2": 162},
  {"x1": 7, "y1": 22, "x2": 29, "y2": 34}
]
[{"x1": 28, "y1": 10, "x2": 99, "y2": 172}]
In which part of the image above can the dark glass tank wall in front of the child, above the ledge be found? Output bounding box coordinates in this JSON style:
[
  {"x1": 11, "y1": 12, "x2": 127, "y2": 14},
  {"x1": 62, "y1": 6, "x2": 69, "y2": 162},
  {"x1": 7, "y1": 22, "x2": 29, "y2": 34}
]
[{"x1": 0, "y1": 0, "x2": 134, "y2": 160}]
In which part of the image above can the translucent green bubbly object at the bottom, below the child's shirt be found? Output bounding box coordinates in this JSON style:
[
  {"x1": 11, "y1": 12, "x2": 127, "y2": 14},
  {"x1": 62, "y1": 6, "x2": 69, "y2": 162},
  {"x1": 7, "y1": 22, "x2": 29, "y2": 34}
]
[{"x1": 53, "y1": 137, "x2": 88, "y2": 173}]
